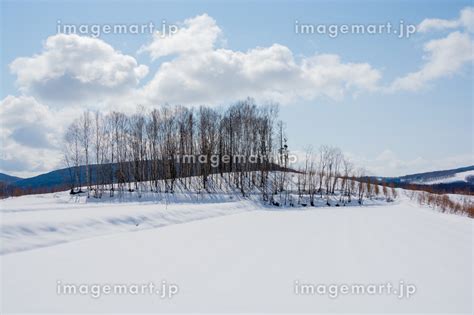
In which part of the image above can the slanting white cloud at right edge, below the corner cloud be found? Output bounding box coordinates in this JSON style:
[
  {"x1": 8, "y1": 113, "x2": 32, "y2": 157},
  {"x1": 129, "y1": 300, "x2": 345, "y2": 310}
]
[{"x1": 390, "y1": 31, "x2": 474, "y2": 91}]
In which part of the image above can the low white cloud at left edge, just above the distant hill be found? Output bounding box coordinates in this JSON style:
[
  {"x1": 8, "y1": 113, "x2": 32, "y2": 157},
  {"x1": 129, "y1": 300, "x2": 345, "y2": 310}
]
[{"x1": 0, "y1": 95, "x2": 73, "y2": 176}]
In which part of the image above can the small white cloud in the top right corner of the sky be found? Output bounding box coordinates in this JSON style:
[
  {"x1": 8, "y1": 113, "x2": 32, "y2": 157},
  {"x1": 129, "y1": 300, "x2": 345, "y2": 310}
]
[{"x1": 417, "y1": 7, "x2": 474, "y2": 33}]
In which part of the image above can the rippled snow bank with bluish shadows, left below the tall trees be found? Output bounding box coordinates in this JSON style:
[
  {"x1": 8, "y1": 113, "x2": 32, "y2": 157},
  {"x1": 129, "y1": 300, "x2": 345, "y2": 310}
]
[{"x1": 0, "y1": 192, "x2": 258, "y2": 254}]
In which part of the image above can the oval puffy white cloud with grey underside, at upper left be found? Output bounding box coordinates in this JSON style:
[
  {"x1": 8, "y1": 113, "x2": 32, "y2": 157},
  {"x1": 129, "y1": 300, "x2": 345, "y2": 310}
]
[{"x1": 10, "y1": 34, "x2": 148, "y2": 103}]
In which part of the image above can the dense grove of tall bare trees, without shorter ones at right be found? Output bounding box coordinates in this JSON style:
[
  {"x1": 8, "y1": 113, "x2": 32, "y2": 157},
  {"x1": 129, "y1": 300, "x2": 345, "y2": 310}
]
[{"x1": 64, "y1": 99, "x2": 287, "y2": 201}]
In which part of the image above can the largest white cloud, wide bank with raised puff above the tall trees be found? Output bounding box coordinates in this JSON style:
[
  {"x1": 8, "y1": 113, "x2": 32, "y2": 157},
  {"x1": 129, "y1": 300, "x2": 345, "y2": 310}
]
[{"x1": 141, "y1": 15, "x2": 381, "y2": 104}]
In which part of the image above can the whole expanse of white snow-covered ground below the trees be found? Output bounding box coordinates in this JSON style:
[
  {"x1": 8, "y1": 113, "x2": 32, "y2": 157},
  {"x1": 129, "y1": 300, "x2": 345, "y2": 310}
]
[{"x1": 0, "y1": 189, "x2": 473, "y2": 314}]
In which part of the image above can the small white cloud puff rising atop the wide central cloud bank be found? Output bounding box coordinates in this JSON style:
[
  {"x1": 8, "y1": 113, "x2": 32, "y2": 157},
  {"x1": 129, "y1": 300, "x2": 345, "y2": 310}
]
[{"x1": 139, "y1": 14, "x2": 222, "y2": 60}]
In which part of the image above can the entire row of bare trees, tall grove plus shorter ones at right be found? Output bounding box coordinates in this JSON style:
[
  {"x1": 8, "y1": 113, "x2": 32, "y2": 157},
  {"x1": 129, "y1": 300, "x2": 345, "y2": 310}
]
[{"x1": 64, "y1": 99, "x2": 396, "y2": 206}]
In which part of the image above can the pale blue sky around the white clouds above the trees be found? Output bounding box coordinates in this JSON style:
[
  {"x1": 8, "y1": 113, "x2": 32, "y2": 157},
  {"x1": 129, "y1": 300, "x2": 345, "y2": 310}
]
[{"x1": 0, "y1": 1, "x2": 473, "y2": 176}]
